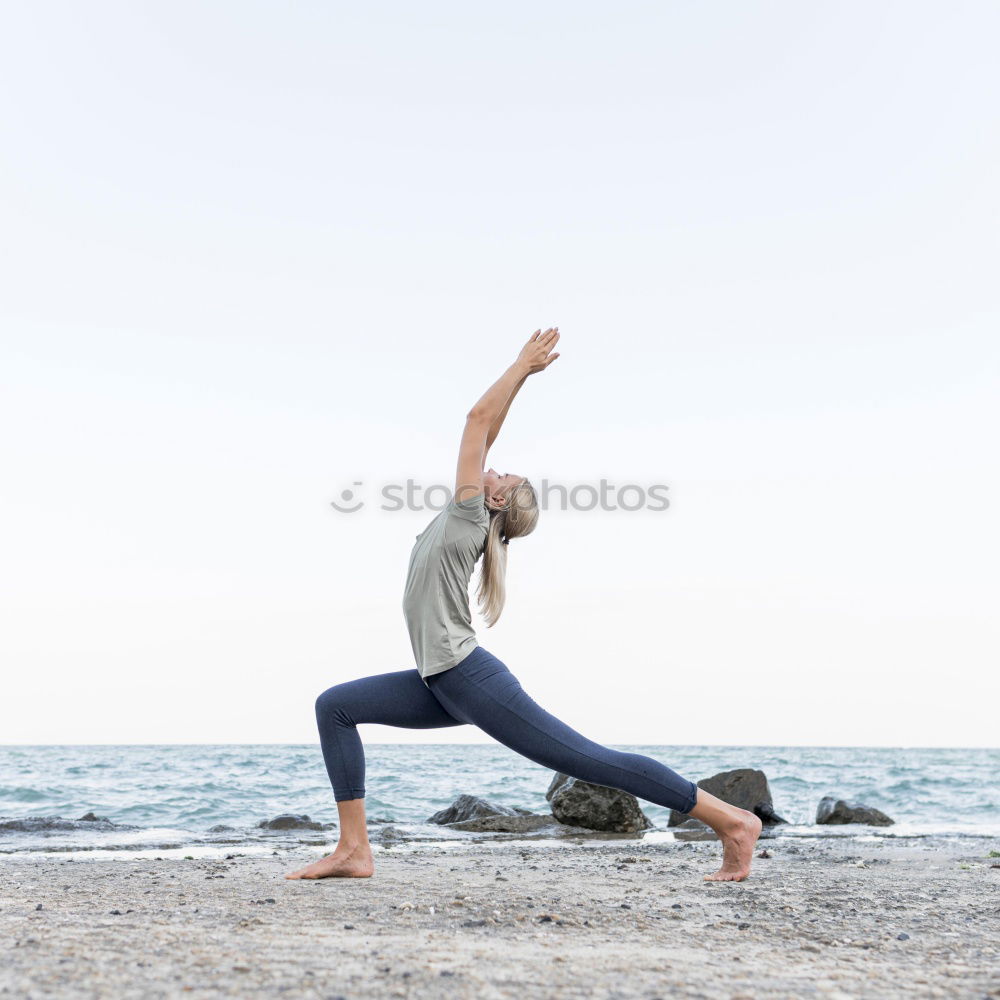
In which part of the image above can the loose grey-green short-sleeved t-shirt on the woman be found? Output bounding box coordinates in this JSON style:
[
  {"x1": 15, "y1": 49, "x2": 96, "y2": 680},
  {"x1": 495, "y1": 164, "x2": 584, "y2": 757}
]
[{"x1": 403, "y1": 493, "x2": 490, "y2": 684}]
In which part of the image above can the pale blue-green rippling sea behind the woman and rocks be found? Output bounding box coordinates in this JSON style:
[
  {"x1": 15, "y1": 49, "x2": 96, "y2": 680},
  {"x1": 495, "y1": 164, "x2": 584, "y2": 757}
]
[{"x1": 0, "y1": 743, "x2": 1000, "y2": 858}]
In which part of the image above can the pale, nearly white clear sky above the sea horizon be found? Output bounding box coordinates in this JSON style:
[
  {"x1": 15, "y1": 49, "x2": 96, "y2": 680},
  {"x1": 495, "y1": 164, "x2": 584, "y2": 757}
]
[{"x1": 0, "y1": 0, "x2": 1000, "y2": 746}]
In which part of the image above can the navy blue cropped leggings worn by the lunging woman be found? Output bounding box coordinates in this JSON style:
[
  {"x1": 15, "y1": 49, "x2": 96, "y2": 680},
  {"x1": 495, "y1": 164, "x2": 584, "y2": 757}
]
[{"x1": 316, "y1": 646, "x2": 698, "y2": 813}]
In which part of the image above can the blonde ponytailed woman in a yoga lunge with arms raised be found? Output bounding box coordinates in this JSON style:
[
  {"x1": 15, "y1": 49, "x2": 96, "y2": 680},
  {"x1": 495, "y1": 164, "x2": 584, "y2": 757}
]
[{"x1": 285, "y1": 327, "x2": 761, "y2": 882}]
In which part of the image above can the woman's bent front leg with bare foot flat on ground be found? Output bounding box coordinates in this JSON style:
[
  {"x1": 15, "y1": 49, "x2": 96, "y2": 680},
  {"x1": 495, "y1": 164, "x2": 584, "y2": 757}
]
[{"x1": 285, "y1": 669, "x2": 463, "y2": 879}]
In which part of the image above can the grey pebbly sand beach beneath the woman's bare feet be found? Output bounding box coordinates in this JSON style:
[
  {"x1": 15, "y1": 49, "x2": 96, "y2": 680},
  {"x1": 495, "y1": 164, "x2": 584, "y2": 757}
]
[{"x1": 0, "y1": 838, "x2": 1000, "y2": 1000}]
